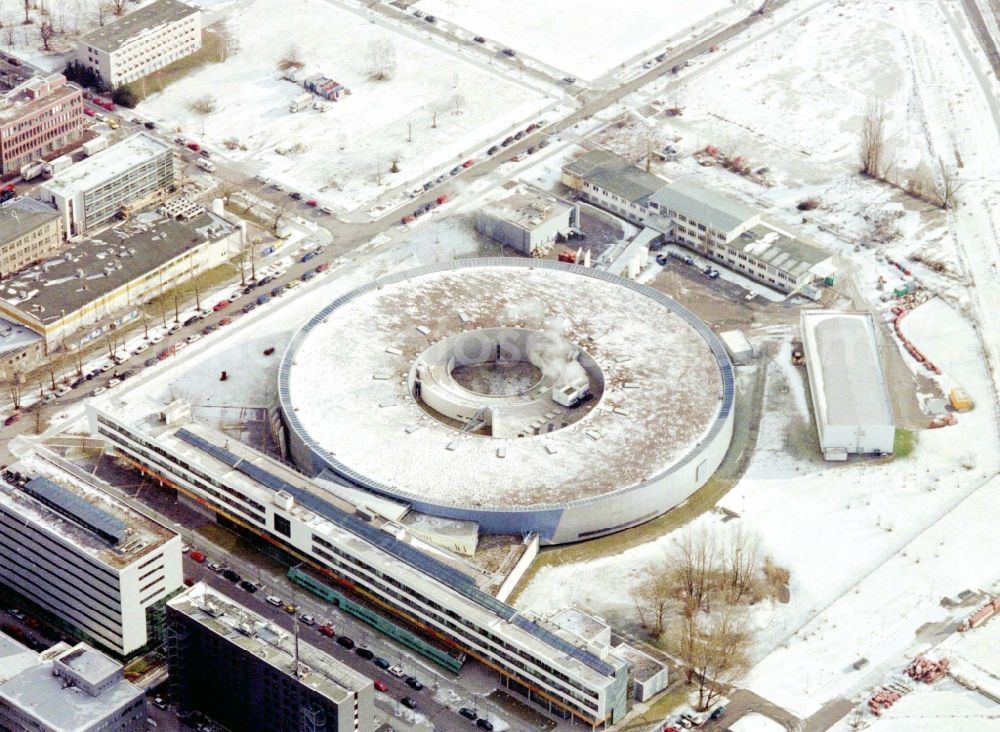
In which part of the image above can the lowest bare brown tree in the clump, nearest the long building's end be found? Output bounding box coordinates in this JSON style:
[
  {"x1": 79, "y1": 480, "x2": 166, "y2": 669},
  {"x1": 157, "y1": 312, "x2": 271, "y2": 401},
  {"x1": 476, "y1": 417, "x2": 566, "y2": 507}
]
[{"x1": 667, "y1": 607, "x2": 753, "y2": 710}]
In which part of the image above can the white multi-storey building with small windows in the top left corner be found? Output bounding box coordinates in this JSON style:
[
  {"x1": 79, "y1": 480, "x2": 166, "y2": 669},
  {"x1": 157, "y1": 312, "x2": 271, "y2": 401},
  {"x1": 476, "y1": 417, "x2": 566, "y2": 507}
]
[{"x1": 76, "y1": 0, "x2": 201, "y2": 87}]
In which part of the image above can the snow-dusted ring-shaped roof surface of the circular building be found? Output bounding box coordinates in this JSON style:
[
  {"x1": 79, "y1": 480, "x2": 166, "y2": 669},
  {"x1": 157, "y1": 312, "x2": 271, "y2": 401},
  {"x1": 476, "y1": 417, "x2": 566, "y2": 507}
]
[{"x1": 280, "y1": 259, "x2": 725, "y2": 507}]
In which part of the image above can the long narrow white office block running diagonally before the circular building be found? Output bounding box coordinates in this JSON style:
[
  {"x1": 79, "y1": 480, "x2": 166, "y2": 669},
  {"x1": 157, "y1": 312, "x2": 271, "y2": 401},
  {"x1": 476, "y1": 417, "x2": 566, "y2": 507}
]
[{"x1": 88, "y1": 408, "x2": 631, "y2": 728}]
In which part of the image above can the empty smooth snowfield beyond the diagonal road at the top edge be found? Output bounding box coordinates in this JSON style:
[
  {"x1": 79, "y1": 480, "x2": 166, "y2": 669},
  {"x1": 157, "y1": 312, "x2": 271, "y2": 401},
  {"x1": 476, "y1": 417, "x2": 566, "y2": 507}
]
[{"x1": 417, "y1": 0, "x2": 750, "y2": 79}]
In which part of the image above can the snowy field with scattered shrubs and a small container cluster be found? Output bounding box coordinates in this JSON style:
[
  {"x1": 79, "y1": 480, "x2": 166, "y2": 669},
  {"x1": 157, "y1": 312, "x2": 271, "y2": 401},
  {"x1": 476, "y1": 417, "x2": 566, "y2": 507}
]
[{"x1": 140, "y1": 0, "x2": 551, "y2": 210}]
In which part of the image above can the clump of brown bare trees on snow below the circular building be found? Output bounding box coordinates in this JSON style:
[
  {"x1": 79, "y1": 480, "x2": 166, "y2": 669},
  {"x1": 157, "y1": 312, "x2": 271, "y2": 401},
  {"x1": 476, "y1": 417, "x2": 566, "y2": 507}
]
[{"x1": 633, "y1": 525, "x2": 788, "y2": 709}]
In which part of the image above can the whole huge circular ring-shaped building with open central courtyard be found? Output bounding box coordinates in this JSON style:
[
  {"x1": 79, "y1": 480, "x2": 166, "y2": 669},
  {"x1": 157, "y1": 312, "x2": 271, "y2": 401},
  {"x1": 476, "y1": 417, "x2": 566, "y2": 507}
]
[{"x1": 279, "y1": 258, "x2": 733, "y2": 544}]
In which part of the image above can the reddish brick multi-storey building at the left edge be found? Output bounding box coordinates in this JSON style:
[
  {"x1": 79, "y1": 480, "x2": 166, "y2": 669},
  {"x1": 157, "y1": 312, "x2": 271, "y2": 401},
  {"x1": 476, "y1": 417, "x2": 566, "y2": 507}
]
[{"x1": 0, "y1": 74, "x2": 83, "y2": 175}]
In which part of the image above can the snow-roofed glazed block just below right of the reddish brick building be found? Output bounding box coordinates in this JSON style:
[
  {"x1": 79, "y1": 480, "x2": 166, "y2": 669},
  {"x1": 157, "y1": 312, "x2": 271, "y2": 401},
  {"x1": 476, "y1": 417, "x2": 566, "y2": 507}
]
[{"x1": 38, "y1": 132, "x2": 174, "y2": 236}]
